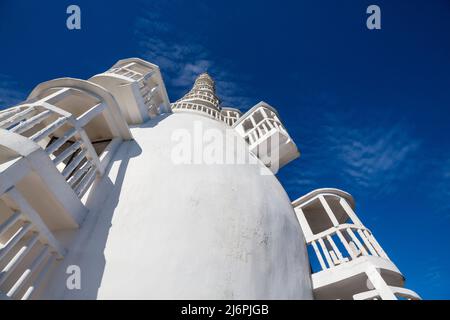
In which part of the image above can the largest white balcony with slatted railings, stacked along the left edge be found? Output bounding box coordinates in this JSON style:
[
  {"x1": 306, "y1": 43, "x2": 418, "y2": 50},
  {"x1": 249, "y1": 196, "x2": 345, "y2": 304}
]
[{"x1": 0, "y1": 78, "x2": 132, "y2": 299}]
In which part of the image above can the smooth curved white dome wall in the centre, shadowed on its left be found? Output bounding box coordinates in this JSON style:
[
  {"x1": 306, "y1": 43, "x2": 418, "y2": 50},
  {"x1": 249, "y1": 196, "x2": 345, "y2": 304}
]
[{"x1": 45, "y1": 113, "x2": 312, "y2": 299}]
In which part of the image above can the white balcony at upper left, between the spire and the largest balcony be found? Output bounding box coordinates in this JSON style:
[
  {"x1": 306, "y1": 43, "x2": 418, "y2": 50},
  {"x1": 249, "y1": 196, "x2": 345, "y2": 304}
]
[{"x1": 89, "y1": 58, "x2": 171, "y2": 124}]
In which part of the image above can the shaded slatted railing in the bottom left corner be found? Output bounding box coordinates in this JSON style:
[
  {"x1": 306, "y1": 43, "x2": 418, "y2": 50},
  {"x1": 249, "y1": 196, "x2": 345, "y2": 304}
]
[{"x1": 0, "y1": 188, "x2": 65, "y2": 300}]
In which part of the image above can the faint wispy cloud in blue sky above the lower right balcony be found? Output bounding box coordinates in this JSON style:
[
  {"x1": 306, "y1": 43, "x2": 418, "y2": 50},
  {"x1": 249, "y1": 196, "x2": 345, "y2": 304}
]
[{"x1": 325, "y1": 117, "x2": 421, "y2": 194}]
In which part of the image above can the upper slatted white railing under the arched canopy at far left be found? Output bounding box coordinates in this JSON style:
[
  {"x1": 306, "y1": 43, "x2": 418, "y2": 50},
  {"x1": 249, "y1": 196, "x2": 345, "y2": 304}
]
[{"x1": 0, "y1": 103, "x2": 104, "y2": 198}]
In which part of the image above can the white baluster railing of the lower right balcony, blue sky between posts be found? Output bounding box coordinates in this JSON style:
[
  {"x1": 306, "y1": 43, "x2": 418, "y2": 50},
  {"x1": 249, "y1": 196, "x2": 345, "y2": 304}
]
[{"x1": 307, "y1": 224, "x2": 389, "y2": 271}]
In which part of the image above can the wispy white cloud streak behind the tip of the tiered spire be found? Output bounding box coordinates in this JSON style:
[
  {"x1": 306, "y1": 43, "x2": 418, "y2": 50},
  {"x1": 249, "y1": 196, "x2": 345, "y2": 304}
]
[{"x1": 135, "y1": 7, "x2": 257, "y2": 109}]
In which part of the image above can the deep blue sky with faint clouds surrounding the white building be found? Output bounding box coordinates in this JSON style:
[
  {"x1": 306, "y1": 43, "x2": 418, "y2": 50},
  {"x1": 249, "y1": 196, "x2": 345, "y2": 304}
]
[{"x1": 0, "y1": 0, "x2": 450, "y2": 299}]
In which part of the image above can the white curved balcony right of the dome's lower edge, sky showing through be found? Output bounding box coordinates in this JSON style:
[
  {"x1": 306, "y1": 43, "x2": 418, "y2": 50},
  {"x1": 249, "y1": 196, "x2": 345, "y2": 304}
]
[{"x1": 292, "y1": 188, "x2": 419, "y2": 300}]
